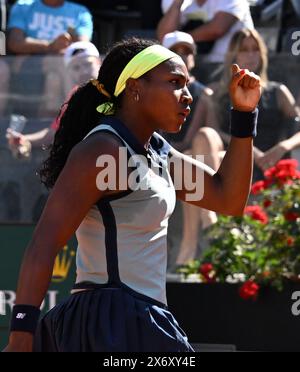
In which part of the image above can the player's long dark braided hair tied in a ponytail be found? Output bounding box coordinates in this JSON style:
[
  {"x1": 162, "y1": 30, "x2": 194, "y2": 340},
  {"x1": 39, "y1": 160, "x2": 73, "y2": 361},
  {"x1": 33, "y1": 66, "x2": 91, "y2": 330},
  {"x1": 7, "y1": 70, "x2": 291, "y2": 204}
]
[{"x1": 39, "y1": 38, "x2": 156, "y2": 189}]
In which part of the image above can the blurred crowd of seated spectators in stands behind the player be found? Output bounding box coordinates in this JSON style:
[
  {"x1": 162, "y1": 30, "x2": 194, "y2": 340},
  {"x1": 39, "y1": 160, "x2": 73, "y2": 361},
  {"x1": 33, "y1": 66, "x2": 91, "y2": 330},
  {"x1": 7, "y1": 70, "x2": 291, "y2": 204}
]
[{"x1": 0, "y1": 0, "x2": 300, "y2": 267}]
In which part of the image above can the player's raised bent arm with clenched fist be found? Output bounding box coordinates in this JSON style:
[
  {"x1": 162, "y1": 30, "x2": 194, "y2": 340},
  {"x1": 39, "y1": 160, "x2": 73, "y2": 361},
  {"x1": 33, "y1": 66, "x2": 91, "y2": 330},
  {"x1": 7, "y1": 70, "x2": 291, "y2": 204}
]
[{"x1": 171, "y1": 65, "x2": 261, "y2": 215}]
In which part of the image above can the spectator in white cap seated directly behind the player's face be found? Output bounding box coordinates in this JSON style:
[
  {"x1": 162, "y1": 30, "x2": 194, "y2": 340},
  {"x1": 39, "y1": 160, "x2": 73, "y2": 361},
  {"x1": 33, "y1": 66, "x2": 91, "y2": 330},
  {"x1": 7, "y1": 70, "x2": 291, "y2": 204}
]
[{"x1": 162, "y1": 31, "x2": 222, "y2": 266}]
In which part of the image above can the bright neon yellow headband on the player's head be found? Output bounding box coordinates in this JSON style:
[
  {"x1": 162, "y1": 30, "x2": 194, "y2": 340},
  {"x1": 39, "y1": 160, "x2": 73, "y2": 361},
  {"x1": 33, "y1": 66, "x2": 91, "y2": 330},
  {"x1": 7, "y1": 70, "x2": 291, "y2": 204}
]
[{"x1": 97, "y1": 45, "x2": 178, "y2": 115}]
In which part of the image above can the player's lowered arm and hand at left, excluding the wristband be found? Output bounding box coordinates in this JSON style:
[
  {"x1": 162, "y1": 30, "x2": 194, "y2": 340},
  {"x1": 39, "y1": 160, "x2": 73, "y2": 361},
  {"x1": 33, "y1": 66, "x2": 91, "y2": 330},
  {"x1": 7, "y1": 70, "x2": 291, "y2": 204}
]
[{"x1": 5, "y1": 133, "x2": 123, "y2": 351}]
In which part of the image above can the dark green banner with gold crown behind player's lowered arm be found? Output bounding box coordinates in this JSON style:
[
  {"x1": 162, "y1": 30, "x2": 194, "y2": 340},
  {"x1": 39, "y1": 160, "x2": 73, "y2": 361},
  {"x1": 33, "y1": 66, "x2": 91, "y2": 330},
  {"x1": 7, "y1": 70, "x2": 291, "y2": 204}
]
[{"x1": 0, "y1": 225, "x2": 77, "y2": 350}]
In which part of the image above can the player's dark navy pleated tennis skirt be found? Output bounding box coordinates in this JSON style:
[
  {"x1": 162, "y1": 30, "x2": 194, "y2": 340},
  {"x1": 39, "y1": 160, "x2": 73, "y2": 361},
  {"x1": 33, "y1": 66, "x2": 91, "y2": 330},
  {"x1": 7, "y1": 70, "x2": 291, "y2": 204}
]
[{"x1": 34, "y1": 286, "x2": 193, "y2": 352}]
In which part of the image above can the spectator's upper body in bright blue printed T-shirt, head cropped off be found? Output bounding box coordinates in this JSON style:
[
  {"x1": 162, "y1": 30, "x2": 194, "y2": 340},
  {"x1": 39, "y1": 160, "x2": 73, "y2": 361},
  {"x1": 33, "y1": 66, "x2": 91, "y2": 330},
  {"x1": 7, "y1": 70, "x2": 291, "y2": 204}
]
[{"x1": 8, "y1": 0, "x2": 93, "y2": 54}]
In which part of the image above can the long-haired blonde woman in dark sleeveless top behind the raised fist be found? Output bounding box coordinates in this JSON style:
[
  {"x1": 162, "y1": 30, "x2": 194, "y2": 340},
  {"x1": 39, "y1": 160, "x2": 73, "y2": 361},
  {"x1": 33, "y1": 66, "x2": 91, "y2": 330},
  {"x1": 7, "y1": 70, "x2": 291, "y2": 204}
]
[{"x1": 187, "y1": 29, "x2": 300, "y2": 181}]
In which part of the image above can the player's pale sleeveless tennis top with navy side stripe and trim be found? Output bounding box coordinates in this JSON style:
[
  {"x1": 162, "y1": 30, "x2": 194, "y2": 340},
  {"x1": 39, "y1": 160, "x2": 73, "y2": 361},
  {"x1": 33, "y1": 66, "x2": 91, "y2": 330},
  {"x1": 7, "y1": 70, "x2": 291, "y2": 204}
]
[{"x1": 76, "y1": 118, "x2": 176, "y2": 304}]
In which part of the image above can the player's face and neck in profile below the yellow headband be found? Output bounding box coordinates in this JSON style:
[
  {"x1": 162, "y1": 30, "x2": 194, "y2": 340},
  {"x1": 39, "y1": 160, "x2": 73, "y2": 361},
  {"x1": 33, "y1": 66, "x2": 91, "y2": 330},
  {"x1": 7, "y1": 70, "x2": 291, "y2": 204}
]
[{"x1": 117, "y1": 58, "x2": 193, "y2": 143}]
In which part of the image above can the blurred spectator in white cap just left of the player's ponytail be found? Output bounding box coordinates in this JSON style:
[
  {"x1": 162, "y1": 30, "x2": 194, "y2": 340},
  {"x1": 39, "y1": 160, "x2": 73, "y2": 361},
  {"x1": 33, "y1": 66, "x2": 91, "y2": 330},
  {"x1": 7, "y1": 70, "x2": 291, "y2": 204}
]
[{"x1": 7, "y1": 41, "x2": 101, "y2": 151}]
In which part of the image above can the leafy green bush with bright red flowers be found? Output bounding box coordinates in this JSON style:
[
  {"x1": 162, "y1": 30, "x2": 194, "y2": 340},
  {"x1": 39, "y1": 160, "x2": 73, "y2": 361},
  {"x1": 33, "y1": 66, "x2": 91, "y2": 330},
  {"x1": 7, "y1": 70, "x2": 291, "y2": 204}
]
[{"x1": 180, "y1": 159, "x2": 300, "y2": 299}]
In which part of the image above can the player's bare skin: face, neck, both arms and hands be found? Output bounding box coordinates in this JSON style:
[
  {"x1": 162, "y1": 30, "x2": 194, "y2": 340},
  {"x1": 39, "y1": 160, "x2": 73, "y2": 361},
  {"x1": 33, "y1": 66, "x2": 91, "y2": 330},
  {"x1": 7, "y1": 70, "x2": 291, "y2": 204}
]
[{"x1": 5, "y1": 57, "x2": 260, "y2": 351}]
